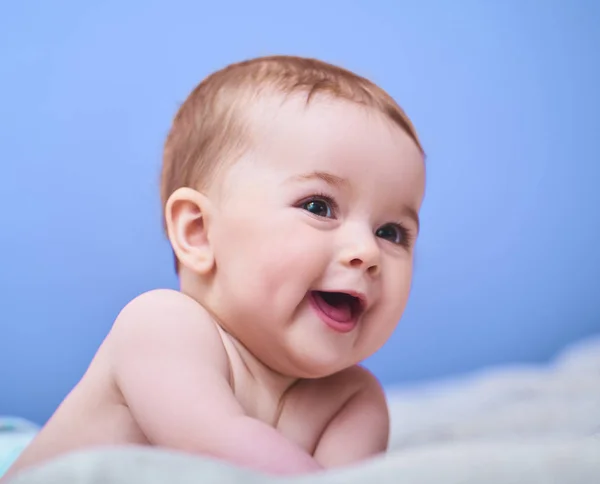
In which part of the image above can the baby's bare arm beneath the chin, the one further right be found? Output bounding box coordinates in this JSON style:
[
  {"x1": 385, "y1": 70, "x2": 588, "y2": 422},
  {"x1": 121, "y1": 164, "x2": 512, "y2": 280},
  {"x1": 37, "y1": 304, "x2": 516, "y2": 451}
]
[{"x1": 314, "y1": 367, "x2": 390, "y2": 468}]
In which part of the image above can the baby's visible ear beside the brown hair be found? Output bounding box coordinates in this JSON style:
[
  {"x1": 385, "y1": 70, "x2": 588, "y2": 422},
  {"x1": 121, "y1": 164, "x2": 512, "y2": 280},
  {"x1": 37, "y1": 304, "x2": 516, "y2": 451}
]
[{"x1": 165, "y1": 187, "x2": 214, "y2": 275}]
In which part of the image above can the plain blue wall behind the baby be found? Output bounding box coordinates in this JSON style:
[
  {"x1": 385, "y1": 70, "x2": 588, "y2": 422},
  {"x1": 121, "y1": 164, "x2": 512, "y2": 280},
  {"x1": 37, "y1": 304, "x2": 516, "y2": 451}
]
[{"x1": 0, "y1": 0, "x2": 600, "y2": 422}]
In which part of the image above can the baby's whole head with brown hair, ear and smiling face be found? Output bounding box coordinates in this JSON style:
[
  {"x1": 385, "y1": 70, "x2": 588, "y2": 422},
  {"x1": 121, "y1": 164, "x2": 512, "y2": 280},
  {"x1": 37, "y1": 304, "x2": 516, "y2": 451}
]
[{"x1": 161, "y1": 57, "x2": 425, "y2": 377}]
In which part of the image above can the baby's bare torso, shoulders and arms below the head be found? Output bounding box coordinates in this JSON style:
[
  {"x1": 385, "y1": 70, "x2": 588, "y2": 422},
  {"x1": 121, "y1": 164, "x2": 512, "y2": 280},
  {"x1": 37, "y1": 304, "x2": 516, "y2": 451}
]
[{"x1": 5, "y1": 290, "x2": 389, "y2": 478}]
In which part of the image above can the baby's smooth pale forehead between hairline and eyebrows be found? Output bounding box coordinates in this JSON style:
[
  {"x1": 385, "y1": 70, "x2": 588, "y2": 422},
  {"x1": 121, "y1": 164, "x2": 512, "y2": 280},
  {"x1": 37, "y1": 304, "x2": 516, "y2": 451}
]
[{"x1": 226, "y1": 96, "x2": 424, "y2": 204}]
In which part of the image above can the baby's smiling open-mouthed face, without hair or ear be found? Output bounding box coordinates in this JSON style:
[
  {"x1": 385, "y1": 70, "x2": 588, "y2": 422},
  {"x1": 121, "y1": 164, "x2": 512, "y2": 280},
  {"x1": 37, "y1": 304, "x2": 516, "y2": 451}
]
[{"x1": 209, "y1": 95, "x2": 425, "y2": 377}]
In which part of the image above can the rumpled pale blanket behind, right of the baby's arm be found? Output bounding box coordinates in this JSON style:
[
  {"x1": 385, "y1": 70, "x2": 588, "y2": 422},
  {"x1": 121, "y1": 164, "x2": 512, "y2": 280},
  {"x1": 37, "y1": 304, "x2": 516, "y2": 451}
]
[{"x1": 388, "y1": 337, "x2": 600, "y2": 448}]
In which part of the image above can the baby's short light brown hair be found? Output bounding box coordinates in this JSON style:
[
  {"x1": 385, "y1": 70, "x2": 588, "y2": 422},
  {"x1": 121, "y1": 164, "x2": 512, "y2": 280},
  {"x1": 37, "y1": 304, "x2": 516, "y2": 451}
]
[{"x1": 160, "y1": 56, "x2": 423, "y2": 269}]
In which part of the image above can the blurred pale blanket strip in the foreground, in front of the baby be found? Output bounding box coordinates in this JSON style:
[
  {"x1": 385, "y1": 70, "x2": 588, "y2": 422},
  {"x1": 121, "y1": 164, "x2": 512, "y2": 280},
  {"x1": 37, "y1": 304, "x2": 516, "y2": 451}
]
[{"x1": 5, "y1": 439, "x2": 600, "y2": 484}]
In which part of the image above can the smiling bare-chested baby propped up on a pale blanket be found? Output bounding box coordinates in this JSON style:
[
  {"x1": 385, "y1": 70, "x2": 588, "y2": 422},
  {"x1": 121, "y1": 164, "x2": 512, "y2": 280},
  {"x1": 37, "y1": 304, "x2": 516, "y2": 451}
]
[{"x1": 9, "y1": 56, "x2": 425, "y2": 475}]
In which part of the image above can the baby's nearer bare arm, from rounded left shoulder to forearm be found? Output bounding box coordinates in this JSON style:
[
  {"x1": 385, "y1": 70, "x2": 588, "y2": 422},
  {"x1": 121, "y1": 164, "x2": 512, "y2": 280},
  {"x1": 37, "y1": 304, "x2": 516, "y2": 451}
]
[{"x1": 113, "y1": 291, "x2": 321, "y2": 474}]
